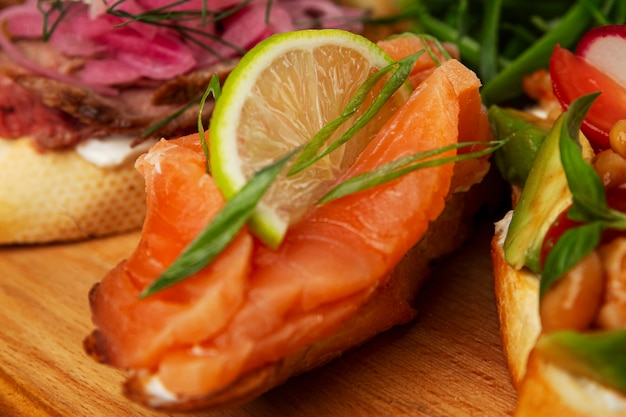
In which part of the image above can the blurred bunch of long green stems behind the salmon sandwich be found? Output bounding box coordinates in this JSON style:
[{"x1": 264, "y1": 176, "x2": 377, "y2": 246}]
[{"x1": 390, "y1": 0, "x2": 626, "y2": 105}]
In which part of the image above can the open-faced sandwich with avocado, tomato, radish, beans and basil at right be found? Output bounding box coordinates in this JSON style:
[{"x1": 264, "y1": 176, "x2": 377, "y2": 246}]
[{"x1": 490, "y1": 25, "x2": 626, "y2": 416}]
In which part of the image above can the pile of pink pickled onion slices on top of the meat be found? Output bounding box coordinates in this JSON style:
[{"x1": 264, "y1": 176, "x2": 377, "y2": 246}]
[{"x1": 0, "y1": 0, "x2": 363, "y2": 94}]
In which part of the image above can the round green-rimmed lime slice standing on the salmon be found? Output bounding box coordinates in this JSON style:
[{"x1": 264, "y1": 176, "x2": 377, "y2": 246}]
[{"x1": 210, "y1": 29, "x2": 410, "y2": 248}]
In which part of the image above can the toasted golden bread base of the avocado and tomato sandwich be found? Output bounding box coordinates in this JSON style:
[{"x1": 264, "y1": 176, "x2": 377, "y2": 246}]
[{"x1": 491, "y1": 212, "x2": 626, "y2": 417}]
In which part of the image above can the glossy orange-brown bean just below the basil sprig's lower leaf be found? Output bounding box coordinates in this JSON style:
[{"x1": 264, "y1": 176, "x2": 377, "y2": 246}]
[{"x1": 539, "y1": 251, "x2": 604, "y2": 332}]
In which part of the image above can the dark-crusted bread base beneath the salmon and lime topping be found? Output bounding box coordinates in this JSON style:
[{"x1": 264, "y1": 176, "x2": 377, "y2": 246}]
[{"x1": 85, "y1": 164, "x2": 502, "y2": 411}]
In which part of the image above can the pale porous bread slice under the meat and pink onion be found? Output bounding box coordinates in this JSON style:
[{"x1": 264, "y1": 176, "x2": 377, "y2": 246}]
[{"x1": 0, "y1": 138, "x2": 146, "y2": 245}]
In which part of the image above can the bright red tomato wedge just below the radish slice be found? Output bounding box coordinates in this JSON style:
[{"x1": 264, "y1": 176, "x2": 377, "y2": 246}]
[{"x1": 550, "y1": 45, "x2": 626, "y2": 150}]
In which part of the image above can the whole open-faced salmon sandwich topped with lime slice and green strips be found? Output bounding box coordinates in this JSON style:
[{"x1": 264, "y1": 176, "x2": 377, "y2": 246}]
[{"x1": 85, "y1": 30, "x2": 498, "y2": 410}]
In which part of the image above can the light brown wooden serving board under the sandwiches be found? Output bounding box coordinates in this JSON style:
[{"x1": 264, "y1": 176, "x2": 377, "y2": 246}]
[{"x1": 0, "y1": 219, "x2": 515, "y2": 417}]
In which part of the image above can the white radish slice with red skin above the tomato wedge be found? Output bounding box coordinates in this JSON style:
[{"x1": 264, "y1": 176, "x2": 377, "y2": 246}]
[{"x1": 576, "y1": 25, "x2": 626, "y2": 88}]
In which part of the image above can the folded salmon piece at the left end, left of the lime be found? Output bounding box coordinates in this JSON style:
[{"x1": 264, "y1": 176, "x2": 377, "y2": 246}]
[{"x1": 90, "y1": 135, "x2": 253, "y2": 369}]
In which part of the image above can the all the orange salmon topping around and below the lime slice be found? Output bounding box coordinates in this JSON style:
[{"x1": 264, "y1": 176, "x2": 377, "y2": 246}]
[{"x1": 87, "y1": 60, "x2": 486, "y2": 401}]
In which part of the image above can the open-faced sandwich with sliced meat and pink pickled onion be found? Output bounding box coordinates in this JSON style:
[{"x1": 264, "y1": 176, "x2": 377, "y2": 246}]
[{"x1": 0, "y1": 0, "x2": 363, "y2": 244}]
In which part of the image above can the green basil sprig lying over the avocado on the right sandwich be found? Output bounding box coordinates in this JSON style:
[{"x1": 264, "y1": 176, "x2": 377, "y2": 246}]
[{"x1": 539, "y1": 93, "x2": 626, "y2": 297}]
